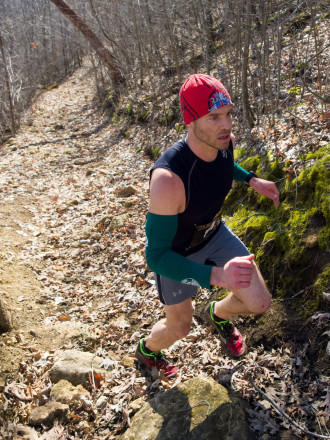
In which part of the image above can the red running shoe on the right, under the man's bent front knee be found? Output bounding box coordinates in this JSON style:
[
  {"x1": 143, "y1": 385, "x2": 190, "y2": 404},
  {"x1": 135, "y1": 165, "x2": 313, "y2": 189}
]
[{"x1": 205, "y1": 301, "x2": 246, "y2": 359}]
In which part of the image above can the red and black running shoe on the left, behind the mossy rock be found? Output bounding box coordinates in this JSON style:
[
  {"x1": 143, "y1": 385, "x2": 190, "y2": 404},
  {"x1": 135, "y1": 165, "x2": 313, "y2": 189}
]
[{"x1": 135, "y1": 339, "x2": 180, "y2": 379}]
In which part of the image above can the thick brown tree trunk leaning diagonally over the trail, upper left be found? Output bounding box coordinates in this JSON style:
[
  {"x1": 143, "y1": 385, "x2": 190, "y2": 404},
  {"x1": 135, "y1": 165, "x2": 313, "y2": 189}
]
[{"x1": 50, "y1": 0, "x2": 125, "y2": 86}]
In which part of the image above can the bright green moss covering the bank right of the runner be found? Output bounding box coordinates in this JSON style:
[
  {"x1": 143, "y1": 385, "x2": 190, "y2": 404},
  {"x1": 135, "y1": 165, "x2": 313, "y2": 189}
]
[{"x1": 224, "y1": 146, "x2": 330, "y2": 314}]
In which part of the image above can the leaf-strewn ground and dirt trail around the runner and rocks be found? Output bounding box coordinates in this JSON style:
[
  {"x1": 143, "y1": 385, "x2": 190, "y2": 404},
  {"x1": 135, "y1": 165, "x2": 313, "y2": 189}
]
[{"x1": 0, "y1": 60, "x2": 330, "y2": 439}]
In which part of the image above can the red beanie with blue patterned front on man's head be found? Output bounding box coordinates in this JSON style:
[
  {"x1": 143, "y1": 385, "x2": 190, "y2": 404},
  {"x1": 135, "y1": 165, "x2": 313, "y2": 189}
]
[{"x1": 179, "y1": 74, "x2": 233, "y2": 125}]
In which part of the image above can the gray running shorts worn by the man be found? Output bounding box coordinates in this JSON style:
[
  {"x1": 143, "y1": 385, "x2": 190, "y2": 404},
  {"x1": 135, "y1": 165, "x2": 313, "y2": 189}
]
[{"x1": 155, "y1": 221, "x2": 250, "y2": 305}]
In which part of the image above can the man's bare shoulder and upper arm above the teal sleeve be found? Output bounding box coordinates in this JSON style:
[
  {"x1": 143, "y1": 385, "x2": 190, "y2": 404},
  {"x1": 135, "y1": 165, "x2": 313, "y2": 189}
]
[{"x1": 149, "y1": 168, "x2": 185, "y2": 215}]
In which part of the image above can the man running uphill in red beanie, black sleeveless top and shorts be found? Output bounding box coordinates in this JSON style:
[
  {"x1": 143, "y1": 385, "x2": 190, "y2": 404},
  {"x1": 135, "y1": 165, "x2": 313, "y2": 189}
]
[{"x1": 135, "y1": 75, "x2": 279, "y2": 378}]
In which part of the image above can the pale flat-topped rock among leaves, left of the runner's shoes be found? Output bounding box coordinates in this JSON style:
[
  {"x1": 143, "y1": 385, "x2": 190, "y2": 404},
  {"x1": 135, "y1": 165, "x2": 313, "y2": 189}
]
[{"x1": 49, "y1": 350, "x2": 114, "y2": 386}]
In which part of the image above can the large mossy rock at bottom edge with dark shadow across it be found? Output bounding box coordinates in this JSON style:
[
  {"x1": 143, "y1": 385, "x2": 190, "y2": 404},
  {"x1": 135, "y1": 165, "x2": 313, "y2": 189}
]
[{"x1": 121, "y1": 377, "x2": 257, "y2": 440}]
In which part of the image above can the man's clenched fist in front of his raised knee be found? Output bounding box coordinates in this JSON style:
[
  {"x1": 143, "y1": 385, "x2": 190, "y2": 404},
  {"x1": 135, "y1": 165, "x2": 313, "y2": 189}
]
[{"x1": 210, "y1": 255, "x2": 256, "y2": 290}]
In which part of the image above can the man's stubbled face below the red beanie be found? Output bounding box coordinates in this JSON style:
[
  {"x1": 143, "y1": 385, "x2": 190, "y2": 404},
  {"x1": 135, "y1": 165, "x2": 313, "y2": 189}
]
[{"x1": 189, "y1": 105, "x2": 233, "y2": 150}]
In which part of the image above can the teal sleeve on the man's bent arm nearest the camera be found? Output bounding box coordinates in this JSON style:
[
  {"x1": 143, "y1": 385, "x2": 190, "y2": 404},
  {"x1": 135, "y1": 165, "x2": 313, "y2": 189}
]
[{"x1": 146, "y1": 212, "x2": 212, "y2": 289}]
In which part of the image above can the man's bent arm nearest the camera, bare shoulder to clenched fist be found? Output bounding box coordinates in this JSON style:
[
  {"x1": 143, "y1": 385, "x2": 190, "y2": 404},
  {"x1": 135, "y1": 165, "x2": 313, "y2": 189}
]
[{"x1": 146, "y1": 168, "x2": 255, "y2": 289}]
